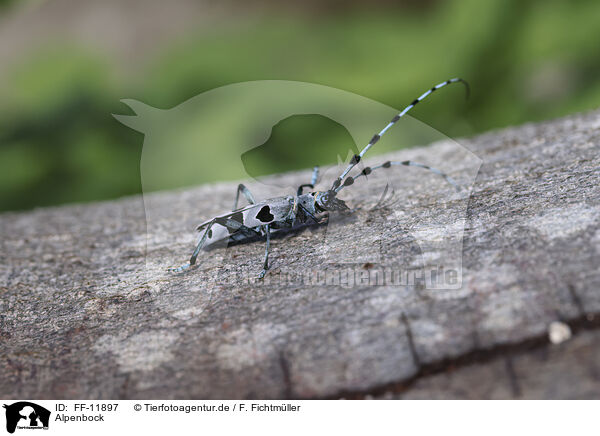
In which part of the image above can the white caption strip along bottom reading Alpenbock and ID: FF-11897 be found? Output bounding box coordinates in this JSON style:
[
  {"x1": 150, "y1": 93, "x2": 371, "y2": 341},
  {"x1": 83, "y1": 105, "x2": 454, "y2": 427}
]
[{"x1": 0, "y1": 400, "x2": 600, "y2": 436}]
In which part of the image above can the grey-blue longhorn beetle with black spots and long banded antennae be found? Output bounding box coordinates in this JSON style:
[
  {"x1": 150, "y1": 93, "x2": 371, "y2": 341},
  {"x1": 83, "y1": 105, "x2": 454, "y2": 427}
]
[{"x1": 169, "y1": 78, "x2": 469, "y2": 279}]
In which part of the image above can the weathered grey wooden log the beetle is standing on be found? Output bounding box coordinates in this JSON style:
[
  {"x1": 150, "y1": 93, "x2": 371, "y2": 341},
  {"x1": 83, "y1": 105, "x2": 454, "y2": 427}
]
[{"x1": 0, "y1": 112, "x2": 600, "y2": 399}]
